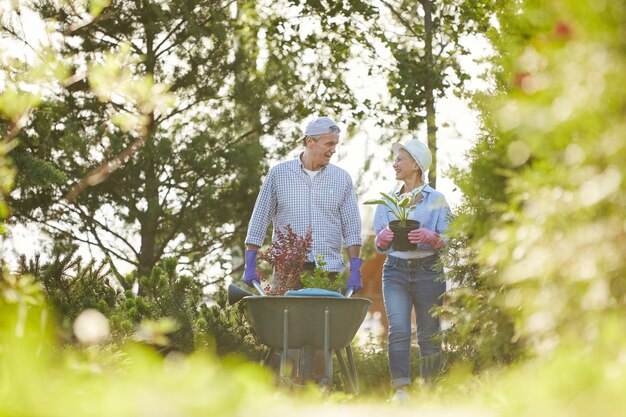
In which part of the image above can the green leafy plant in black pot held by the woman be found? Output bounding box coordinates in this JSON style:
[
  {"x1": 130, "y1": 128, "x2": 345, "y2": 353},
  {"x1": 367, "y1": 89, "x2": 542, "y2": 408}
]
[{"x1": 363, "y1": 186, "x2": 424, "y2": 251}]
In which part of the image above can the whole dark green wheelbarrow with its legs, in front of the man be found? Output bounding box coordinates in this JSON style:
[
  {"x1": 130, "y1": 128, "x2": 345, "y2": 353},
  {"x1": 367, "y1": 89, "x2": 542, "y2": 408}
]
[{"x1": 228, "y1": 284, "x2": 372, "y2": 395}]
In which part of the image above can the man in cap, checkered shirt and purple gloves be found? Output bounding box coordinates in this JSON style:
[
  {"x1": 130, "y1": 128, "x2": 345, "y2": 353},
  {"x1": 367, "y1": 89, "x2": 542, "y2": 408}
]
[{"x1": 244, "y1": 117, "x2": 362, "y2": 292}]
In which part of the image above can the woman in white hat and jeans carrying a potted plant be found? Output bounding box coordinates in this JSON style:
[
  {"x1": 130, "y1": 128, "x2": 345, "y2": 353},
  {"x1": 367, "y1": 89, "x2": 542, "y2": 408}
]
[{"x1": 374, "y1": 140, "x2": 450, "y2": 400}]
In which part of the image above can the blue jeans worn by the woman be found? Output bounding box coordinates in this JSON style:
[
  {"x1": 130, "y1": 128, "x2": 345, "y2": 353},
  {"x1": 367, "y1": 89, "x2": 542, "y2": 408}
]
[{"x1": 383, "y1": 254, "x2": 446, "y2": 388}]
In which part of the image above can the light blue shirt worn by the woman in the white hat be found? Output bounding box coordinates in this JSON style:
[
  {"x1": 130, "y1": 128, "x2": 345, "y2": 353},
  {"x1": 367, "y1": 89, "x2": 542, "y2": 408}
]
[{"x1": 374, "y1": 185, "x2": 451, "y2": 257}]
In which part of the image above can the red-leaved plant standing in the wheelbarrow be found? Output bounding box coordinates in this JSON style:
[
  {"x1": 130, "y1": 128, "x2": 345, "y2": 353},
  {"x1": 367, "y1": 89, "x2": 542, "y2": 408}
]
[{"x1": 257, "y1": 225, "x2": 313, "y2": 295}]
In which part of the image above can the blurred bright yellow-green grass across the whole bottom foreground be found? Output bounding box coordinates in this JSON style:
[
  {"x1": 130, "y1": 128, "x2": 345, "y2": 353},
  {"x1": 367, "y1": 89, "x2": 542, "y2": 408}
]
[{"x1": 0, "y1": 234, "x2": 626, "y2": 417}]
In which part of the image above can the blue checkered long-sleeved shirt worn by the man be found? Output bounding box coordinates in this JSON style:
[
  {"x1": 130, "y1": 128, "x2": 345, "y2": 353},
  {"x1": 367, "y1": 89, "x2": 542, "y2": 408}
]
[{"x1": 246, "y1": 157, "x2": 362, "y2": 272}]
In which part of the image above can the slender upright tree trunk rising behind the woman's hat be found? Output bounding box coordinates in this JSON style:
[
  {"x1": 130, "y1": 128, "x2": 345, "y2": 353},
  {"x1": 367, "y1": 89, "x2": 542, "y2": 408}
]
[{"x1": 420, "y1": 0, "x2": 437, "y2": 188}]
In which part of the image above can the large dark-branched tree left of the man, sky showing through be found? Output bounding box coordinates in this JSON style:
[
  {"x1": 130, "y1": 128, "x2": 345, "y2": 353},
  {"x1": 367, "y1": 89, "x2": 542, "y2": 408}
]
[{"x1": 4, "y1": 0, "x2": 352, "y2": 285}]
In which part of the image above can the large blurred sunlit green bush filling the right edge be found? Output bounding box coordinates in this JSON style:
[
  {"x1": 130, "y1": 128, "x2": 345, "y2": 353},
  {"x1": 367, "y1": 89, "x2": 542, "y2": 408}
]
[{"x1": 448, "y1": 1, "x2": 626, "y2": 370}]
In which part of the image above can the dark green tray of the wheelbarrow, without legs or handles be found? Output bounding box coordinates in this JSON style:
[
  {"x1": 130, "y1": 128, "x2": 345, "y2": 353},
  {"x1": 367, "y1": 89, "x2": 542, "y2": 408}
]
[{"x1": 243, "y1": 296, "x2": 372, "y2": 350}]
